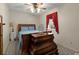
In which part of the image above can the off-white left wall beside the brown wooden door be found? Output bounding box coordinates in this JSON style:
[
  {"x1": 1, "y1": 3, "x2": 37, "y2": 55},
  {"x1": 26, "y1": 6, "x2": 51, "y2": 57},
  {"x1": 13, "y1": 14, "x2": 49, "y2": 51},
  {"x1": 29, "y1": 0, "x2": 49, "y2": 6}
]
[{"x1": 0, "y1": 4, "x2": 9, "y2": 54}]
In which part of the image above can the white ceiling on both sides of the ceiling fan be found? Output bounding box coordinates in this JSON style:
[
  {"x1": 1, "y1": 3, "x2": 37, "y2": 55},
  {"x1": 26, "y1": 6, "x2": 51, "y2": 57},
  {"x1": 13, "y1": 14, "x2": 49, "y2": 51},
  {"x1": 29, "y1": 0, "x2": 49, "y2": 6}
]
[{"x1": 7, "y1": 3, "x2": 63, "y2": 14}]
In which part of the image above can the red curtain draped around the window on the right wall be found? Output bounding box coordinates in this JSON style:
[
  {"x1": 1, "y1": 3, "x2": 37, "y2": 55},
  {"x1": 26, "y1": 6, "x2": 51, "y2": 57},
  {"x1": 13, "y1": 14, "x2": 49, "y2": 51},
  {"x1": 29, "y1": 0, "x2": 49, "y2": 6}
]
[{"x1": 46, "y1": 12, "x2": 59, "y2": 33}]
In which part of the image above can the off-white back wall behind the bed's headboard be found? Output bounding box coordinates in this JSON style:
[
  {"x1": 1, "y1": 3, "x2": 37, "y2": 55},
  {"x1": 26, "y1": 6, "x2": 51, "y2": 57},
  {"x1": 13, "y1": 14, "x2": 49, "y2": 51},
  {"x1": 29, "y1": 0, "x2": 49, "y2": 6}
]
[{"x1": 10, "y1": 10, "x2": 40, "y2": 36}]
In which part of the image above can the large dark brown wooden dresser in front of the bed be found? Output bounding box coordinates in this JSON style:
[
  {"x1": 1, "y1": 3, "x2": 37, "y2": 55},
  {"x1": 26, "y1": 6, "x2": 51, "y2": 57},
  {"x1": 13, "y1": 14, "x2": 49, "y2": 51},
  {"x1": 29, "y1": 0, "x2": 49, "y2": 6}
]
[{"x1": 30, "y1": 33, "x2": 58, "y2": 55}]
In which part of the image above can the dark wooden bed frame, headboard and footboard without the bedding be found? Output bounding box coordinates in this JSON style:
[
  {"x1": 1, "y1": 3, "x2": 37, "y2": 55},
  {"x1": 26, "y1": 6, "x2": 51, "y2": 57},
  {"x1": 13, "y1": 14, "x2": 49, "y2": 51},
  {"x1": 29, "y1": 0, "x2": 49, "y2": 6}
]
[{"x1": 17, "y1": 24, "x2": 36, "y2": 54}]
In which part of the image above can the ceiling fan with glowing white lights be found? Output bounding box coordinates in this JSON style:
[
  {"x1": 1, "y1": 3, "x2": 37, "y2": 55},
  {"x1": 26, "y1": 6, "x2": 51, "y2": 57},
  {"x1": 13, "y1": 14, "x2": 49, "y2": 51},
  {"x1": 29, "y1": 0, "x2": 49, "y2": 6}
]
[{"x1": 24, "y1": 3, "x2": 46, "y2": 13}]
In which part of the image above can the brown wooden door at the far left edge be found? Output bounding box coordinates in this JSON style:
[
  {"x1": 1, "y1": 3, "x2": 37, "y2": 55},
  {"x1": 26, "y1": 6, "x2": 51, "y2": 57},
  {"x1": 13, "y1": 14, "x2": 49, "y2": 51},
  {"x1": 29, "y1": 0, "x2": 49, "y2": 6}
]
[{"x1": 0, "y1": 16, "x2": 3, "y2": 55}]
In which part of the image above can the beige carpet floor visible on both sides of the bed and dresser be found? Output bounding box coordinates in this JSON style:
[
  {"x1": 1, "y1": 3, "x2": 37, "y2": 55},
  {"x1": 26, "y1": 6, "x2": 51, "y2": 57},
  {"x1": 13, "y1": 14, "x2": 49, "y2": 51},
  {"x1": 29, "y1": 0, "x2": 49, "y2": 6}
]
[{"x1": 5, "y1": 41, "x2": 79, "y2": 55}]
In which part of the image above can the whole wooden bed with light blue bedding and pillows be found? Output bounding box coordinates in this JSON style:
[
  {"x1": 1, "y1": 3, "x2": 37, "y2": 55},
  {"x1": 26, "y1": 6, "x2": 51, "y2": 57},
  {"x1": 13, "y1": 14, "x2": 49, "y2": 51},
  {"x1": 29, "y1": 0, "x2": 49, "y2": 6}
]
[{"x1": 18, "y1": 24, "x2": 51, "y2": 53}]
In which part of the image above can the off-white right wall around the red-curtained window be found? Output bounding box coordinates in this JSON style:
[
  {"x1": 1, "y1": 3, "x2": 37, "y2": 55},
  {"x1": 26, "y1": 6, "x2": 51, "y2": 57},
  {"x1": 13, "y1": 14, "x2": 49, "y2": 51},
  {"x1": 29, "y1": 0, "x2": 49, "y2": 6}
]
[{"x1": 41, "y1": 4, "x2": 79, "y2": 51}]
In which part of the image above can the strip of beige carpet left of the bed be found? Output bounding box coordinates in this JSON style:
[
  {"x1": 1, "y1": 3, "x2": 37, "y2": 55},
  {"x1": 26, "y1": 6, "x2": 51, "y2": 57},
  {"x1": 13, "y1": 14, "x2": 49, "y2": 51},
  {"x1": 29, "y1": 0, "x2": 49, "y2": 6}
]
[{"x1": 5, "y1": 41, "x2": 20, "y2": 55}]
